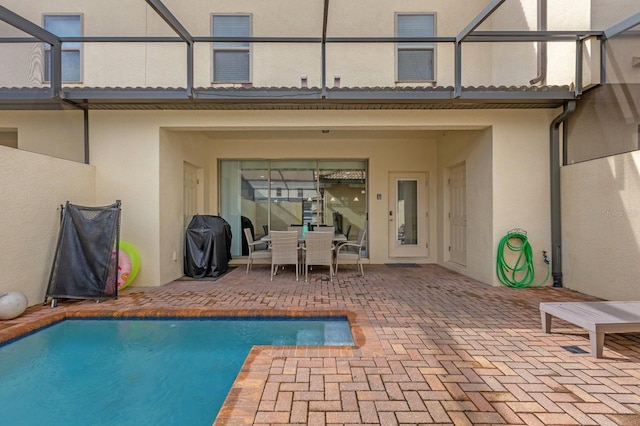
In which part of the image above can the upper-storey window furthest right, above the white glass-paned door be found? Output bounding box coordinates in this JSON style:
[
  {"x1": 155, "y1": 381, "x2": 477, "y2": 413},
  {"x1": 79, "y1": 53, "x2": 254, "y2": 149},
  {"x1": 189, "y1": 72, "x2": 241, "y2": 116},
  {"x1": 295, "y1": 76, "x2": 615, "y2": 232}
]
[{"x1": 396, "y1": 14, "x2": 435, "y2": 81}]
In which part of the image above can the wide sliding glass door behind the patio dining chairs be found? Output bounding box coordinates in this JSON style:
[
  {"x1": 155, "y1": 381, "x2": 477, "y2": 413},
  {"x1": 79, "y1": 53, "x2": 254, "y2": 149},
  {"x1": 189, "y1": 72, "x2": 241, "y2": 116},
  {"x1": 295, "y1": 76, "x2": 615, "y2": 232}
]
[{"x1": 219, "y1": 160, "x2": 367, "y2": 256}]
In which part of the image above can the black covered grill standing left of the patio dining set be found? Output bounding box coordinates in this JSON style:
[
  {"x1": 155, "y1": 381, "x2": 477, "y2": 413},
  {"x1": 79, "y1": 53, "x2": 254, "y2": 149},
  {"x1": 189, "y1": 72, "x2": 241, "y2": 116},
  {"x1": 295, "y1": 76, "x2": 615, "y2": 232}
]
[{"x1": 184, "y1": 215, "x2": 231, "y2": 278}]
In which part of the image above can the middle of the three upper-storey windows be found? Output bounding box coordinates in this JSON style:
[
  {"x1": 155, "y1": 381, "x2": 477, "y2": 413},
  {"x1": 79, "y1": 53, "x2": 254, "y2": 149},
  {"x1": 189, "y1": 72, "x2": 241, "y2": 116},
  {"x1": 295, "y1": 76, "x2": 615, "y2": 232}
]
[{"x1": 212, "y1": 15, "x2": 251, "y2": 83}]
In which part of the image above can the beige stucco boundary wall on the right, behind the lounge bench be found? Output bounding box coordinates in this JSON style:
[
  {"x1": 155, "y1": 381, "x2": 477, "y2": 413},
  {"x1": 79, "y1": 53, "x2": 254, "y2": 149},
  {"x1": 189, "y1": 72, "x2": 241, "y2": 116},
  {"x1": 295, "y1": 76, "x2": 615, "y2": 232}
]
[{"x1": 561, "y1": 151, "x2": 640, "y2": 300}]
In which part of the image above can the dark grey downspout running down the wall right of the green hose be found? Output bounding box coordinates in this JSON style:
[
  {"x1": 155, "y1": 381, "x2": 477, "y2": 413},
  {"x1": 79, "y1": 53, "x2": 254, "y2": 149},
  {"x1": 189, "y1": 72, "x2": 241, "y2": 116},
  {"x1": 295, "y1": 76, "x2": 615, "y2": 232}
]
[{"x1": 550, "y1": 101, "x2": 576, "y2": 287}]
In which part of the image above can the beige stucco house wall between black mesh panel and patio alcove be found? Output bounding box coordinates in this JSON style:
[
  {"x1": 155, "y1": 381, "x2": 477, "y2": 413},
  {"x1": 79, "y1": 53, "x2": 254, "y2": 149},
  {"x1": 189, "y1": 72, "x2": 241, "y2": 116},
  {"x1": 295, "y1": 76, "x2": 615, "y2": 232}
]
[{"x1": 89, "y1": 111, "x2": 164, "y2": 285}]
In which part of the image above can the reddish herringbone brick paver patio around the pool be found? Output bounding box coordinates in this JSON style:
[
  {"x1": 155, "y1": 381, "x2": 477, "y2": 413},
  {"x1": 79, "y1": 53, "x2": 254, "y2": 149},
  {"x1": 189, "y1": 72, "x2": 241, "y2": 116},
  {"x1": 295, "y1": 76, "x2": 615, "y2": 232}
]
[{"x1": 0, "y1": 265, "x2": 640, "y2": 425}]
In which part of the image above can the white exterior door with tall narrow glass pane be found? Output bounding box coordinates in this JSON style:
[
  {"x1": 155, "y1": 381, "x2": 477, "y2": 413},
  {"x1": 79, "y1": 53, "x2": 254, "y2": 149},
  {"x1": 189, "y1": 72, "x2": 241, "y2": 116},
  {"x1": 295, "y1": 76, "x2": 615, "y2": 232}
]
[{"x1": 388, "y1": 172, "x2": 429, "y2": 257}]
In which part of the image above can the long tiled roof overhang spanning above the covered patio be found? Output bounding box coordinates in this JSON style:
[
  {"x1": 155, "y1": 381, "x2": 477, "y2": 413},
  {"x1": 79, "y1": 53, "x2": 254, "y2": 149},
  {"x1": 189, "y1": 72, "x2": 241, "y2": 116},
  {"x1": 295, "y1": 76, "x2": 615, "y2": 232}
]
[{"x1": 0, "y1": 86, "x2": 575, "y2": 110}]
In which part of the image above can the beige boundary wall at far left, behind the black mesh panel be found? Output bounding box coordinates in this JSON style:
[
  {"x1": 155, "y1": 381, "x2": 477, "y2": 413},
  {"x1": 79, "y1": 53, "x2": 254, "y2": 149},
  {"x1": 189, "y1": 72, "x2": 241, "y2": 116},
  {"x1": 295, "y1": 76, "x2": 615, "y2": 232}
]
[{"x1": 0, "y1": 146, "x2": 95, "y2": 305}]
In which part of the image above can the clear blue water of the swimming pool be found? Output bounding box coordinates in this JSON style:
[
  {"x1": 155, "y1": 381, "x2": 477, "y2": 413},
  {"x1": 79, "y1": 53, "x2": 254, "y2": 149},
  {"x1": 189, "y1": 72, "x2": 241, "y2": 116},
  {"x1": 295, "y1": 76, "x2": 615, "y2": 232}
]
[{"x1": 0, "y1": 319, "x2": 353, "y2": 426}]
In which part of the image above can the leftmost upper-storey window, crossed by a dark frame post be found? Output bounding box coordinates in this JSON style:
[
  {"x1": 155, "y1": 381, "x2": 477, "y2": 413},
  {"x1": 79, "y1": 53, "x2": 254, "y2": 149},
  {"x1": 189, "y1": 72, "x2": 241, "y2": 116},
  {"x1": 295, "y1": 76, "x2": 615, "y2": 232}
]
[{"x1": 44, "y1": 15, "x2": 82, "y2": 82}]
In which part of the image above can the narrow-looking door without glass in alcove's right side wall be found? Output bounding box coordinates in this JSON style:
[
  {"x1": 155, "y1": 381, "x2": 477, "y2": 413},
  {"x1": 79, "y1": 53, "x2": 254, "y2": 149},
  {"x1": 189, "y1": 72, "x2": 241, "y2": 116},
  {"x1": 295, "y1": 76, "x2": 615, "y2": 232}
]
[{"x1": 449, "y1": 163, "x2": 467, "y2": 266}]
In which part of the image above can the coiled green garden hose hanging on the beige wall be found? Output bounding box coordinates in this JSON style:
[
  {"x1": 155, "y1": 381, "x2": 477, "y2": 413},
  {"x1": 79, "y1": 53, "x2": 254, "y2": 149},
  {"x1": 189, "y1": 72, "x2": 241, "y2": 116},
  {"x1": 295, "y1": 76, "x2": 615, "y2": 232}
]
[{"x1": 496, "y1": 229, "x2": 551, "y2": 288}]
